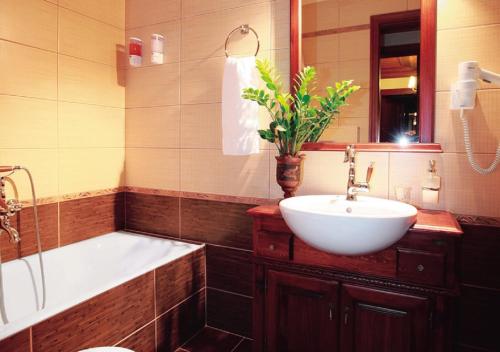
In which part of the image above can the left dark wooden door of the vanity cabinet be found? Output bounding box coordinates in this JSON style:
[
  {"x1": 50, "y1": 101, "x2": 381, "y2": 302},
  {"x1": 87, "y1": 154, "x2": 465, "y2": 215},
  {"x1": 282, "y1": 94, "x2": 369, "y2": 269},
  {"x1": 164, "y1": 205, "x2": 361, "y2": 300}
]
[{"x1": 265, "y1": 271, "x2": 338, "y2": 352}]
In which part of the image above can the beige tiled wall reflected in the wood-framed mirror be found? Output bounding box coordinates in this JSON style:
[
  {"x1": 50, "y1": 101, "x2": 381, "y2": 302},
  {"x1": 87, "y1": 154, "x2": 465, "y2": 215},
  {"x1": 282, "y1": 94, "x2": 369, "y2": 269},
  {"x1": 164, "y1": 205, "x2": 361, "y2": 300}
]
[{"x1": 302, "y1": 0, "x2": 420, "y2": 143}]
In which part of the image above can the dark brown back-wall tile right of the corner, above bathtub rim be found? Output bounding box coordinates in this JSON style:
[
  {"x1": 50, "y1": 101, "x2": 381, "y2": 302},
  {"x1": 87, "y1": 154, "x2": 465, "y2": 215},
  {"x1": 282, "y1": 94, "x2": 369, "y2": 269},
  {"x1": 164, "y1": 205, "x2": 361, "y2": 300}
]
[{"x1": 125, "y1": 192, "x2": 179, "y2": 237}]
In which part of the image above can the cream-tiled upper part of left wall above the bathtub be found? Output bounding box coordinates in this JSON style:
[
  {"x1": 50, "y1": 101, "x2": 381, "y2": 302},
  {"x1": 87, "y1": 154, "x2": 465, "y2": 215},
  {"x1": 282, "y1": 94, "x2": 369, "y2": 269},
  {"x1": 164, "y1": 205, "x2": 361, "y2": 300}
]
[{"x1": 0, "y1": 0, "x2": 125, "y2": 200}]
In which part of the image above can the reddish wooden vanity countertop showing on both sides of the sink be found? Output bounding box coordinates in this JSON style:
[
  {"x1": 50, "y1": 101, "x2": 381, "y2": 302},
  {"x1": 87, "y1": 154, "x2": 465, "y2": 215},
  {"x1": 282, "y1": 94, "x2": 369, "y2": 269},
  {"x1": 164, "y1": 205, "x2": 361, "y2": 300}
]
[{"x1": 247, "y1": 205, "x2": 463, "y2": 236}]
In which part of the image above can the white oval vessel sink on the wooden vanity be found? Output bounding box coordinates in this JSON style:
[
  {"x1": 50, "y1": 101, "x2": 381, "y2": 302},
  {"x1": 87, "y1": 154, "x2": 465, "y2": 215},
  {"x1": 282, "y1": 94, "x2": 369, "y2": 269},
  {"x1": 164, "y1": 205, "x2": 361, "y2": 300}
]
[{"x1": 280, "y1": 195, "x2": 417, "y2": 255}]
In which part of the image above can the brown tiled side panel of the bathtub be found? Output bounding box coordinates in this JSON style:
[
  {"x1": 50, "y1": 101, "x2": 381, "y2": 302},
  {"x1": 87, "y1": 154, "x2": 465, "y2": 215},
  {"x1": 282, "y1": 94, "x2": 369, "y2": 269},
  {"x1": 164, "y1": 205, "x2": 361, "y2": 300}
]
[{"x1": 0, "y1": 248, "x2": 206, "y2": 352}]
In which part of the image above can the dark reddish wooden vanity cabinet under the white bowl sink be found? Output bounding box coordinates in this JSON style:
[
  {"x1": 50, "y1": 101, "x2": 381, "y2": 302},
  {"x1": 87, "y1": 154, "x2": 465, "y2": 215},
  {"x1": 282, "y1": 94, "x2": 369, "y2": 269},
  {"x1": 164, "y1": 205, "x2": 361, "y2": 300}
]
[{"x1": 249, "y1": 207, "x2": 460, "y2": 352}]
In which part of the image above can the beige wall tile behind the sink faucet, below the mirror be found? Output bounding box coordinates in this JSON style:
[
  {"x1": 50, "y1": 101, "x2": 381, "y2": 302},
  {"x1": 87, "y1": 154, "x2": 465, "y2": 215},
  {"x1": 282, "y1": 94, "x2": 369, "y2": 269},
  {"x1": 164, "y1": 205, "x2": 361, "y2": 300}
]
[{"x1": 298, "y1": 152, "x2": 389, "y2": 198}]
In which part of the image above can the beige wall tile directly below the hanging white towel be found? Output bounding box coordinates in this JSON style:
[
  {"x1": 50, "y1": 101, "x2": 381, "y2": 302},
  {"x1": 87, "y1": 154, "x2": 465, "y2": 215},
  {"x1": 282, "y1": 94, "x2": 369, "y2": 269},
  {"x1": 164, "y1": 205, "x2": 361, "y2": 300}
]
[{"x1": 181, "y1": 149, "x2": 269, "y2": 198}]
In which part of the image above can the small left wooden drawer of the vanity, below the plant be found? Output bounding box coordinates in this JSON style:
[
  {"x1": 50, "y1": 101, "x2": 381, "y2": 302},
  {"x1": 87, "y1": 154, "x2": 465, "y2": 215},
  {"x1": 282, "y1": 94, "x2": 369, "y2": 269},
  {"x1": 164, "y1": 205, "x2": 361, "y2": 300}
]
[{"x1": 255, "y1": 231, "x2": 292, "y2": 260}]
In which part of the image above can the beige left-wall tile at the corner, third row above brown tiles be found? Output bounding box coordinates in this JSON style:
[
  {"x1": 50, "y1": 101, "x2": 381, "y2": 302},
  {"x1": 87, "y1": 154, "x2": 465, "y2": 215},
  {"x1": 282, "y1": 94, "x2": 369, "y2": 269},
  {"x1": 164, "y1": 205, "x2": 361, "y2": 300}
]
[{"x1": 59, "y1": 55, "x2": 125, "y2": 107}]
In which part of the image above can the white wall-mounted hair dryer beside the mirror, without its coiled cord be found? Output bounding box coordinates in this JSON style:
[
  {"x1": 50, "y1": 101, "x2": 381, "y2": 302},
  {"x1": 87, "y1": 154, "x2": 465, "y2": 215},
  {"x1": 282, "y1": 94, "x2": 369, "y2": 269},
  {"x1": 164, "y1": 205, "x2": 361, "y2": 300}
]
[{"x1": 451, "y1": 61, "x2": 500, "y2": 110}]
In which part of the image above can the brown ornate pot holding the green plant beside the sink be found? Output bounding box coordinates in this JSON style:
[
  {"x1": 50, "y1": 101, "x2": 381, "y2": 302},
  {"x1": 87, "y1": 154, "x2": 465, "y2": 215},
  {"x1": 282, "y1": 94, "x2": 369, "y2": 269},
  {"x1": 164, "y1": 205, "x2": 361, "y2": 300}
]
[{"x1": 276, "y1": 155, "x2": 305, "y2": 198}]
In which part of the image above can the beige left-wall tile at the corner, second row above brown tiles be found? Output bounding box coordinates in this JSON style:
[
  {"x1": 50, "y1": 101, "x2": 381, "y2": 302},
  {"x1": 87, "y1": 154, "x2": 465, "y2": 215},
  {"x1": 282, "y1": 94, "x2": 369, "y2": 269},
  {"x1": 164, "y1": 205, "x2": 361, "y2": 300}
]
[{"x1": 58, "y1": 102, "x2": 125, "y2": 148}]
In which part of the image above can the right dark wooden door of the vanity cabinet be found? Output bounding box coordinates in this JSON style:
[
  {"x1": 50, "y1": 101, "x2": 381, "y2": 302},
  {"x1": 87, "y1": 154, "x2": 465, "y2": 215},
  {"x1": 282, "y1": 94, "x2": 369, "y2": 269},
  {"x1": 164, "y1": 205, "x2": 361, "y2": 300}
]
[{"x1": 340, "y1": 285, "x2": 430, "y2": 352}]
